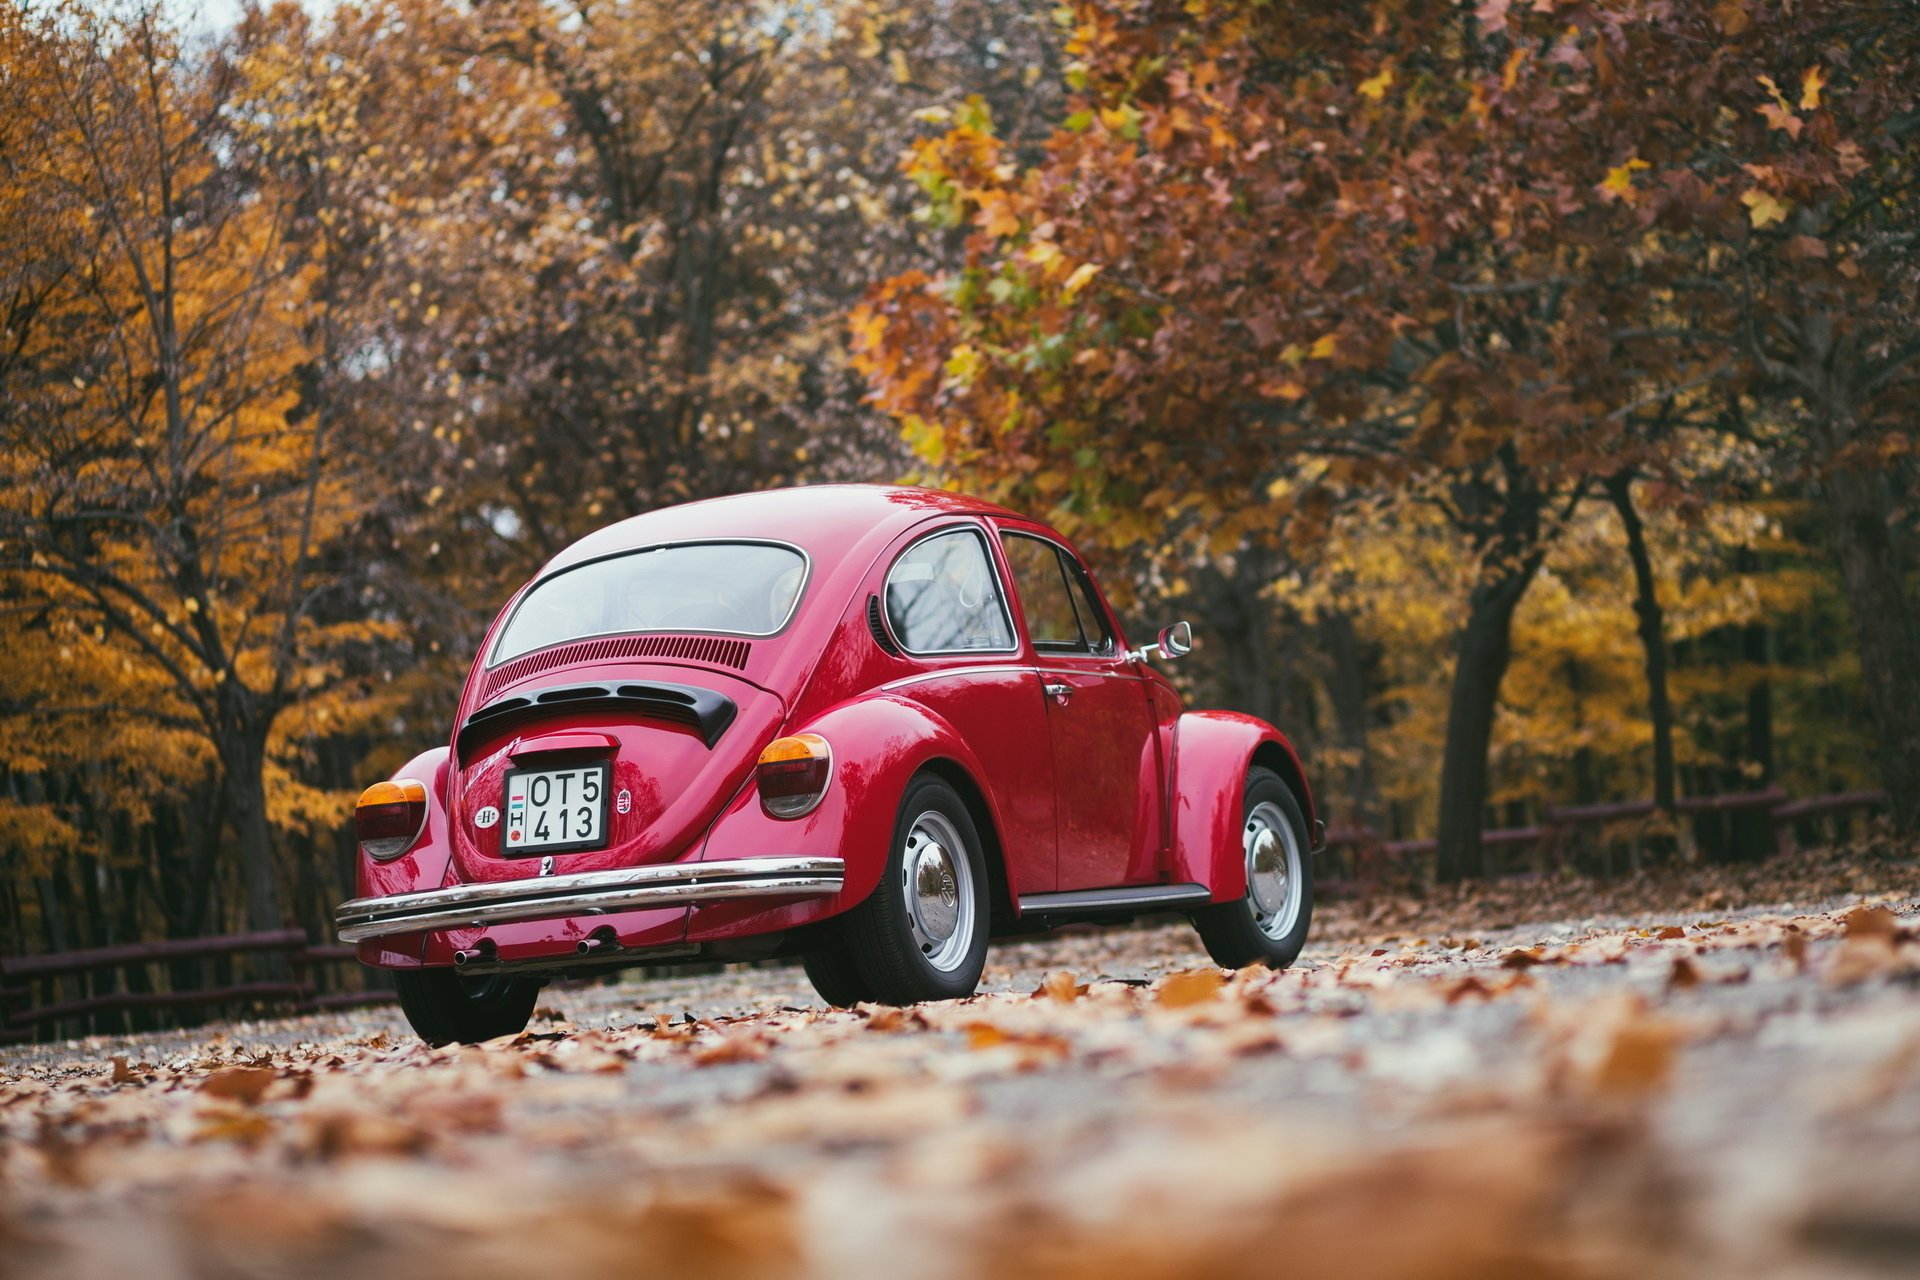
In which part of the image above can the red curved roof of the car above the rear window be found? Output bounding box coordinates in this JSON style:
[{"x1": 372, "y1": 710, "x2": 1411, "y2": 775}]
[{"x1": 540, "y1": 484, "x2": 1023, "y2": 578}]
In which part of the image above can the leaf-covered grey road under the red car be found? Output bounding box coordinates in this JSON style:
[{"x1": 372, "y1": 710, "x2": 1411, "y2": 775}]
[{"x1": 0, "y1": 892, "x2": 1920, "y2": 1280}]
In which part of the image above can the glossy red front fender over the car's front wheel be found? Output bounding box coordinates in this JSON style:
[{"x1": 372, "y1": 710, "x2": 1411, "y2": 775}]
[{"x1": 1171, "y1": 712, "x2": 1317, "y2": 902}]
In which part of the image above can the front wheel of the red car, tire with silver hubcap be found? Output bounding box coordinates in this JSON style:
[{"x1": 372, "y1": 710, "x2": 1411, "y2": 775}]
[{"x1": 1192, "y1": 766, "x2": 1313, "y2": 969}]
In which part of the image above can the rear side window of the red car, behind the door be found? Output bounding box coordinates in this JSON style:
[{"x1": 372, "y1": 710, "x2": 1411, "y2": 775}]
[{"x1": 887, "y1": 528, "x2": 1014, "y2": 654}]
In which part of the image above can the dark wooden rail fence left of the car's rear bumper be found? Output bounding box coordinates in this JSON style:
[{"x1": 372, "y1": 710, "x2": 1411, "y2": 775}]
[{"x1": 0, "y1": 929, "x2": 394, "y2": 1042}]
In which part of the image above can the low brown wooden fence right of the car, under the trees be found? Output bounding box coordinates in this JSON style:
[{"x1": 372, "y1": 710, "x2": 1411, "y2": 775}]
[{"x1": 1319, "y1": 787, "x2": 1887, "y2": 892}]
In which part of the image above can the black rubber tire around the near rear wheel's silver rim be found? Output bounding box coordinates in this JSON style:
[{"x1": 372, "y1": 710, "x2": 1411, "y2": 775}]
[{"x1": 840, "y1": 773, "x2": 989, "y2": 1004}]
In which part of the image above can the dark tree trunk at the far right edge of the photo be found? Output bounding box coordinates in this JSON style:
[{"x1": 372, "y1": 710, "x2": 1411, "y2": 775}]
[{"x1": 1828, "y1": 466, "x2": 1920, "y2": 835}]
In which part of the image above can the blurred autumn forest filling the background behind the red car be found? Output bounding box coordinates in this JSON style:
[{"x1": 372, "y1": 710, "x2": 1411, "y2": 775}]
[{"x1": 0, "y1": 0, "x2": 1920, "y2": 952}]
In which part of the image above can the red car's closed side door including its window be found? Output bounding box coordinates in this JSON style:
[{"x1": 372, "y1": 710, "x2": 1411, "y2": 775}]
[{"x1": 1000, "y1": 526, "x2": 1160, "y2": 892}]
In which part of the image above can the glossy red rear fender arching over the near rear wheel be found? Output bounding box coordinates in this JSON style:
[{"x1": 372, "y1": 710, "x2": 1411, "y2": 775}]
[{"x1": 687, "y1": 697, "x2": 1018, "y2": 942}]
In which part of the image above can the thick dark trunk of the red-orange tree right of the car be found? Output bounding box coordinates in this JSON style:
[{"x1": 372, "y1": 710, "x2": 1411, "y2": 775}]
[{"x1": 1436, "y1": 551, "x2": 1542, "y2": 883}]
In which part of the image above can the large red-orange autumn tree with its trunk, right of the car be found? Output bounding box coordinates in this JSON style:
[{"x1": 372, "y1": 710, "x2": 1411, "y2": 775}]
[{"x1": 852, "y1": 2, "x2": 1912, "y2": 877}]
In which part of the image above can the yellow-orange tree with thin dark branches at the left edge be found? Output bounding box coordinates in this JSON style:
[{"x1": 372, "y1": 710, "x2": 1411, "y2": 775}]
[{"x1": 0, "y1": 6, "x2": 395, "y2": 929}]
